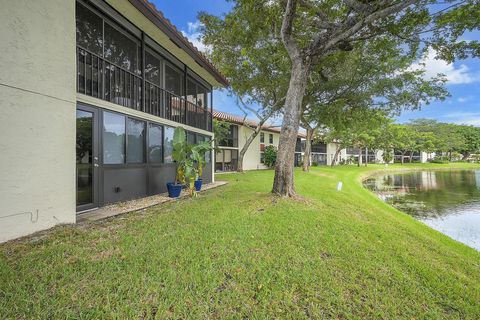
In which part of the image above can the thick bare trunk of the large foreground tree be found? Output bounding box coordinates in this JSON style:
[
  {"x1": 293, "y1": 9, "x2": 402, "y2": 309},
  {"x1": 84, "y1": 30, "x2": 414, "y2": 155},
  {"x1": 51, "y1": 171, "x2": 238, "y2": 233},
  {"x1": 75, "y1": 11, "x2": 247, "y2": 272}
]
[{"x1": 272, "y1": 58, "x2": 310, "y2": 197}]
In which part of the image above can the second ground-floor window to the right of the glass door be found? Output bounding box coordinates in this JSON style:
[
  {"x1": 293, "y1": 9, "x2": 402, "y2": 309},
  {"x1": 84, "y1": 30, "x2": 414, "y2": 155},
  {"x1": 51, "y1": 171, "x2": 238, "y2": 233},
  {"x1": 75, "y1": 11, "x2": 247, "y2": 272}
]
[{"x1": 127, "y1": 118, "x2": 145, "y2": 163}]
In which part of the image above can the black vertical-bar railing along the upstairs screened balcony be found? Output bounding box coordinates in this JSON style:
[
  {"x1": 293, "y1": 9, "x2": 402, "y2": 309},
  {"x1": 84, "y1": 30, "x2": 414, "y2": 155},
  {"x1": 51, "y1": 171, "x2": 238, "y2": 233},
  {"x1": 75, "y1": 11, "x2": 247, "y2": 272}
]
[{"x1": 77, "y1": 47, "x2": 213, "y2": 131}]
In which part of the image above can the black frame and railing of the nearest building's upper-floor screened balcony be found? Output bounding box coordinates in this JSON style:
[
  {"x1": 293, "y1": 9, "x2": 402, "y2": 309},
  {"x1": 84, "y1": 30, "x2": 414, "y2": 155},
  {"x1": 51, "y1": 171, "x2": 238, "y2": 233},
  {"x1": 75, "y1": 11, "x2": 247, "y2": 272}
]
[{"x1": 75, "y1": 0, "x2": 213, "y2": 132}]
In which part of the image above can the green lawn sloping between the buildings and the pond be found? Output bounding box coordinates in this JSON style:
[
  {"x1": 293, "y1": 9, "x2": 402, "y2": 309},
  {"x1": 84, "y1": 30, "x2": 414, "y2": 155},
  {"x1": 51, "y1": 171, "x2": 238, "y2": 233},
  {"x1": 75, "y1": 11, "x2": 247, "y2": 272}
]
[{"x1": 0, "y1": 164, "x2": 480, "y2": 319}]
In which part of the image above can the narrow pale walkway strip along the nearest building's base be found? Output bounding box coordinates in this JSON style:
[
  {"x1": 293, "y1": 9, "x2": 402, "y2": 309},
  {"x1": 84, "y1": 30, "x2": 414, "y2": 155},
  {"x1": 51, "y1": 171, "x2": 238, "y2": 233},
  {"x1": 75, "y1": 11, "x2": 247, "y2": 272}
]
[{"x1": 77, "y1": 181, "x2": 227, "y2": 223}]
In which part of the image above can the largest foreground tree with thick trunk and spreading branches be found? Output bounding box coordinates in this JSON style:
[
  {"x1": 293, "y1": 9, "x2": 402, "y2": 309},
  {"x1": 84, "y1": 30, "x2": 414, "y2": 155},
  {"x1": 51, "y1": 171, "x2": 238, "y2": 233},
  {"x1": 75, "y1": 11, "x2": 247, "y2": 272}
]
[{"x1": 202, "y1": 0, "x2": 473, "y2": 196}]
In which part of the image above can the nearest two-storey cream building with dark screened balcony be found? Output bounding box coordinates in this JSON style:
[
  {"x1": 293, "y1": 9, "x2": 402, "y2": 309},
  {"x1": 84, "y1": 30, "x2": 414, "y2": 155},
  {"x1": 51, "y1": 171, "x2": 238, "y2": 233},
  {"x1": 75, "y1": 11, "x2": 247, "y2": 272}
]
[{"x1": 0, "y1": 0, "x2": 227, "y2": 241}]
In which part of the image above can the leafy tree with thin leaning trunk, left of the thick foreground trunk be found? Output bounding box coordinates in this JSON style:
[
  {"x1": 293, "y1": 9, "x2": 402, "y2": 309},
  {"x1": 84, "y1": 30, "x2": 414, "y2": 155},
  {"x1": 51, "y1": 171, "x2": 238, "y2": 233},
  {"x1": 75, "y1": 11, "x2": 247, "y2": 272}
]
[{"x1": 199, "y1": 7, "x2": 290, "y2": 172}]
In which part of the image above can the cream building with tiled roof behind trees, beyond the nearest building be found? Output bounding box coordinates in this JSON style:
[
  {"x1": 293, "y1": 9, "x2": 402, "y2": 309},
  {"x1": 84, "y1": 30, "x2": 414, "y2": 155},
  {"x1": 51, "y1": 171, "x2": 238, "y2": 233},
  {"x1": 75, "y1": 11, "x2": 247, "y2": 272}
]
[{"x1": 213, "y1": 111, "x2": 304, "y2": 172}]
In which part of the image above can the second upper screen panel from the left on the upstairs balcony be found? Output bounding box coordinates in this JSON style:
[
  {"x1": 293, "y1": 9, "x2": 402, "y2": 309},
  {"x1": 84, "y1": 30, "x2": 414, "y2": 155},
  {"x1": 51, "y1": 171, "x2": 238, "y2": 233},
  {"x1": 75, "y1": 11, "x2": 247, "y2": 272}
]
[{"x1": 104, "y1": 23, "x2": 141, "y2": 74}]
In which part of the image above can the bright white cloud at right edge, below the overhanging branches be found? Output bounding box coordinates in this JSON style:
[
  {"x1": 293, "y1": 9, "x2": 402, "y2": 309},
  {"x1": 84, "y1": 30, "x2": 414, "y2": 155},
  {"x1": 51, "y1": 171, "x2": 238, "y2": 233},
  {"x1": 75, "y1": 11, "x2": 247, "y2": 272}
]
[{"x1": 411, "y1": 49, "x2": 480, "y2": 84}]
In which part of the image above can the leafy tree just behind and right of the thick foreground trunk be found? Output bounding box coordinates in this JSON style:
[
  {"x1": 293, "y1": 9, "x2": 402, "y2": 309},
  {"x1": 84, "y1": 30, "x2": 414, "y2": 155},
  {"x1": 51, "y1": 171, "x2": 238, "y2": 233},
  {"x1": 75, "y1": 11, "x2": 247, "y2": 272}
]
[{"x1": 301, "y1": 38, "x2": 448, "y2": 171}]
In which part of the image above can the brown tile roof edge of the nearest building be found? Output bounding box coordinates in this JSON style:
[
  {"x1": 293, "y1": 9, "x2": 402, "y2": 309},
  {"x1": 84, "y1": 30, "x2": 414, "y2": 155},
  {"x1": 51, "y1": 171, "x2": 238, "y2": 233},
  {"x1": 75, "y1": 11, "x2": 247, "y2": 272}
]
[{"x1": 129, "y1": 0, "x2": 229, "y2": 86}]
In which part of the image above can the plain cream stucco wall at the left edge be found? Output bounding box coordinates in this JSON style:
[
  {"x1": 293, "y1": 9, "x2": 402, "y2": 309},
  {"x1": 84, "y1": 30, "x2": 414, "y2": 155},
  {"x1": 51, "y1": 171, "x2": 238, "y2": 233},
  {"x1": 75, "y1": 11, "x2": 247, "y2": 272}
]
[{"x1": 0, "y1": 0, "x2": 75, "y2": 242}]
